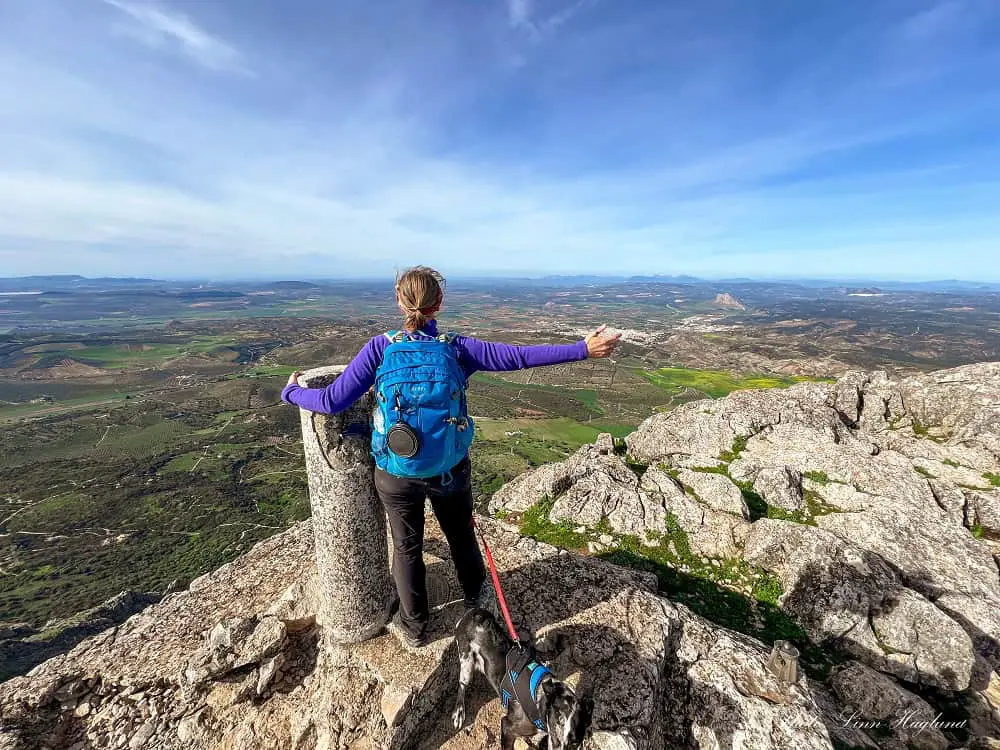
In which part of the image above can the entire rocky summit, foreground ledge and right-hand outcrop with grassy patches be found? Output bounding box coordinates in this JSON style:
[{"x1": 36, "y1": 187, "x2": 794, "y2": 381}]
[{"x1": 0, "y1": 364, "x2": 1000, "y2": 750}]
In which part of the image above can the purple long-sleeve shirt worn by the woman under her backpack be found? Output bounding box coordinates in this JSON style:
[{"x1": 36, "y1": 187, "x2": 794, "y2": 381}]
[{"x1": 281, "y1": 320, "x2": 587, "y2": 414}]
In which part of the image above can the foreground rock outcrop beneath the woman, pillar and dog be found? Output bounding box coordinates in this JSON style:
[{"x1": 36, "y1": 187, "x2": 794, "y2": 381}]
[{"x1": 0, "y1": 519, "x2": 841, "y2": 750}]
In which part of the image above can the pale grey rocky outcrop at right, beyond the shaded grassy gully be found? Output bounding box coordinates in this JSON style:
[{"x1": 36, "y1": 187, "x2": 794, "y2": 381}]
[{"x1": 493, "y1": 364, "x2": 1000, "y2": 724}]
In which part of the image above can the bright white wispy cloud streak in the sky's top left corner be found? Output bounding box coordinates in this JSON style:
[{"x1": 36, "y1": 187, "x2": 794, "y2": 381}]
[{"x1": 104, "y1": 0, "x2": 249, "y2": 74}]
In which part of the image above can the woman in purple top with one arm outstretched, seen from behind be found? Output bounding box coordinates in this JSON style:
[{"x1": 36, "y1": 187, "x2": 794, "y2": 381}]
[{"x1": 281, "y1": 266, "x2": 620, "y2": 648}]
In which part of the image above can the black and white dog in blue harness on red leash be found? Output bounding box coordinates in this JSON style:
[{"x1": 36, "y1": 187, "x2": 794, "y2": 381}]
[{"x1": 452, "y1": 609, "x2": 593, "y2": 750}]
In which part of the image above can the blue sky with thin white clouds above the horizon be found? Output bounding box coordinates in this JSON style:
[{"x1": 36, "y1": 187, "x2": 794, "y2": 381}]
[{"x1": 0, "y1": 0, "x2": 1000, "y2": 280}]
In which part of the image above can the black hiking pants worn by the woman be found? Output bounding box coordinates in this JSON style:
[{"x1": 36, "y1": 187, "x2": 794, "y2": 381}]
[{"x1": 375, "y1": 456, "x2": 486, "y2": 635}]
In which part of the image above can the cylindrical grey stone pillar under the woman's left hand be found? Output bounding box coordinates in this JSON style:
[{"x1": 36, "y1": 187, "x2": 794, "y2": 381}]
[{"x1": 299, "y1": 365, "x2": 396, "y2": 644}]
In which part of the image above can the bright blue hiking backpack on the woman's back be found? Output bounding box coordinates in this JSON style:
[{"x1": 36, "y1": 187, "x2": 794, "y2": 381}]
[{"x1": 372, "y1": 331, "x2": 474, "y2": 478}]
